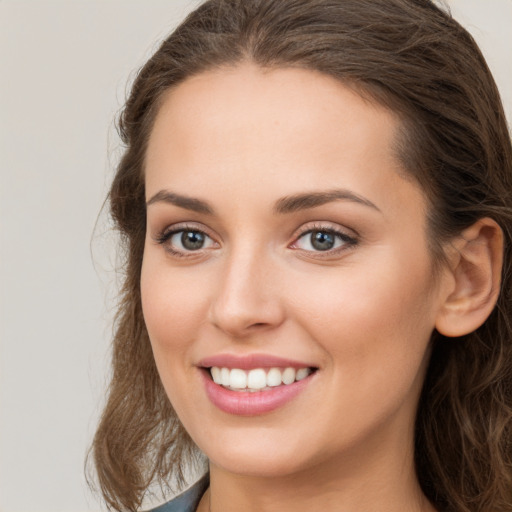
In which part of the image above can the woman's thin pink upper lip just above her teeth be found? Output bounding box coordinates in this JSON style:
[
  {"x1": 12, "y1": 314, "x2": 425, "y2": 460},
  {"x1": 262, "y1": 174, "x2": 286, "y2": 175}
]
[{"x1": 198, "y1": 354, "x2": 315, "y2": 370}]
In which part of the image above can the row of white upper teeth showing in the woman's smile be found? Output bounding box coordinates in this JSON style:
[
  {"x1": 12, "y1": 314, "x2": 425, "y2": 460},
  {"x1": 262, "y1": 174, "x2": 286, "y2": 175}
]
[{"x1": 210, "y1": 366, "x2": 311, "y2": 391}]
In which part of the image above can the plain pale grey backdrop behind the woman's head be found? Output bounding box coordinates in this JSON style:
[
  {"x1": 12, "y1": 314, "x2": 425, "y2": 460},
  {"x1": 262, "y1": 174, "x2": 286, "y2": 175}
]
[{"x1": 0, "y1": 0, "x2": 512, "y2": 512}]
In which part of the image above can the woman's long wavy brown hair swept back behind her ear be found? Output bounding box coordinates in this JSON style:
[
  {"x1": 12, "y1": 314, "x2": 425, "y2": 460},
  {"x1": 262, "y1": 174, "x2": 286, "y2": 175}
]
[{"x1": 92, "y1": 0, "x2": 512, "y2": 512}]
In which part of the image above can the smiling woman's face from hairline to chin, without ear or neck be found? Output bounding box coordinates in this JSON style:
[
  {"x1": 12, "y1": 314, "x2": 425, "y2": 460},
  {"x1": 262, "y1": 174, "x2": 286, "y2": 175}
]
[{"x1": 141, "y1": 64, "x2": 450, "y2": 476}]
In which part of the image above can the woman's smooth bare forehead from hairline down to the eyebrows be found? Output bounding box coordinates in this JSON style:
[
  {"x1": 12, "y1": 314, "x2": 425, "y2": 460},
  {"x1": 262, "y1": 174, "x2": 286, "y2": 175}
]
[{"x1": 146, "y1": 63, "x2": 424, "y2": 220}]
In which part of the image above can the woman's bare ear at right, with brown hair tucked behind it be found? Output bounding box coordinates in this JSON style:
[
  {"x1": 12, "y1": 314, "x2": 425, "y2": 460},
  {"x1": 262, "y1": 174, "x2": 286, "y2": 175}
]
[{"x1": 436, "y1": 218, "x2": 503, "y2": 337}]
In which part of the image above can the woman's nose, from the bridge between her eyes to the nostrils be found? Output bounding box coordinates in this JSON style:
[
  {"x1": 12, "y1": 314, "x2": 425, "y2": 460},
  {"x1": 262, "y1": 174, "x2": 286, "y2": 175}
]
[{"x1": 210, "y1": 247, "x2": 285, "y2": 338}]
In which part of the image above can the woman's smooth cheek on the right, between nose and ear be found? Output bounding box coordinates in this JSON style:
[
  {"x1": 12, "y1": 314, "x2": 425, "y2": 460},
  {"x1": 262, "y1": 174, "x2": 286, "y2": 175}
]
[{"x1": 295, "y1": 251, "x2": 435, "y2": 384}]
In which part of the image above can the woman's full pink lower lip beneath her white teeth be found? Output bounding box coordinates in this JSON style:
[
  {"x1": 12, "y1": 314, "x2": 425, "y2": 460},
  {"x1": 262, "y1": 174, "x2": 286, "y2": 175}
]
[{"x1": 201, "y1": 370, "x2": 314, "y2": 416}]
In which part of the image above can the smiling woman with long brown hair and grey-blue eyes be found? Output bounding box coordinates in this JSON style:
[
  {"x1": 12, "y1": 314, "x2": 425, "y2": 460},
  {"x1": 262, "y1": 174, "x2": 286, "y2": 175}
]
[{"x1": 93, "y1": 0, "x2": 512, "y2": 512}]
